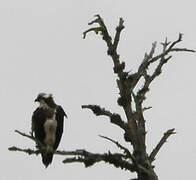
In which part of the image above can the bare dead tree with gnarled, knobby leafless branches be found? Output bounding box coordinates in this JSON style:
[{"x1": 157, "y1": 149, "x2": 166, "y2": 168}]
[{"x1": 9, "y1": 15, "x2": 195, "y2": 180}]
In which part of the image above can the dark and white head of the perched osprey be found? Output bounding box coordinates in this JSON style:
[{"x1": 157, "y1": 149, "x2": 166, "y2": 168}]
[{"x1": 35, "y1": 93, "x2": 56, "y2": 108}]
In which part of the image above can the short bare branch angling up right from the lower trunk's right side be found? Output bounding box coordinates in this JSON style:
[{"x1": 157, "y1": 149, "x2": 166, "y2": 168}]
[{"x1": 149, "y1": 129, "x2": 176, "y2": 162}]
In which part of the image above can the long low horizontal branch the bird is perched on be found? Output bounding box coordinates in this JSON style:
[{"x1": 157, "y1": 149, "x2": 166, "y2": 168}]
[{"x1": 8, "y1": 145, "x2": 146, "y2": 172}]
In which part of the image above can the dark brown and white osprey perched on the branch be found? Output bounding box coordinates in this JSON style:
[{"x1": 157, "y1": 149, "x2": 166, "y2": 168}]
[{"x1": 32, "y1": 93, "x2": 67, "y2": 168}]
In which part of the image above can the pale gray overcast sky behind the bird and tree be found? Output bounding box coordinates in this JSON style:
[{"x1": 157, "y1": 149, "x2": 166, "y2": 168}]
[{"x1": 0, "y1": 0, "x2": 196, "y2": 180}]
